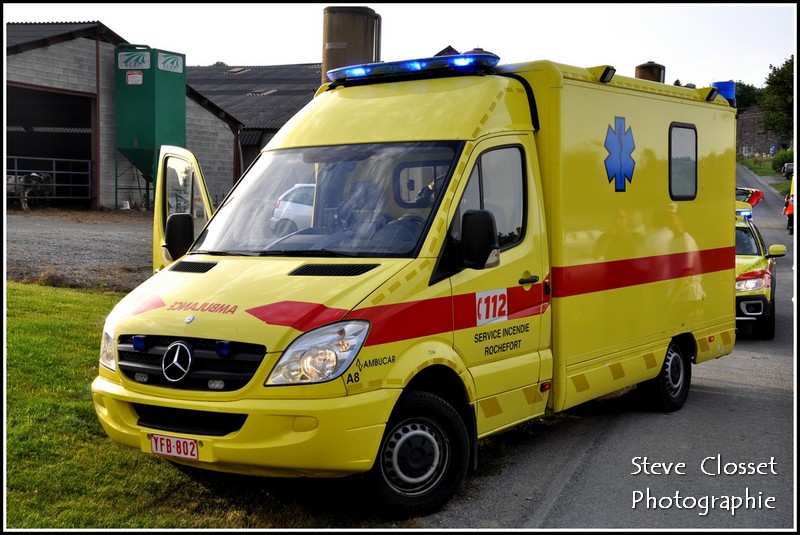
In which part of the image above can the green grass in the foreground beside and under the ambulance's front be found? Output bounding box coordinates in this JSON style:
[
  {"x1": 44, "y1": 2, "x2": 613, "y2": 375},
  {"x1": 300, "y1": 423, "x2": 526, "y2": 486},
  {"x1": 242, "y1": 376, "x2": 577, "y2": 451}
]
[{"x1": 5, "y1": 281, "x2": 415, "y2": 529}]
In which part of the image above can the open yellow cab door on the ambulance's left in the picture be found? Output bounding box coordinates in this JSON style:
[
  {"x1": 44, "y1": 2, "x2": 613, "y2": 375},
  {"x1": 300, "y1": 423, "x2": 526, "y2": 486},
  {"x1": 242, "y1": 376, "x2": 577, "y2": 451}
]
[{"x1": 153, "y1": 145, "x2": 214, "y2": 273}]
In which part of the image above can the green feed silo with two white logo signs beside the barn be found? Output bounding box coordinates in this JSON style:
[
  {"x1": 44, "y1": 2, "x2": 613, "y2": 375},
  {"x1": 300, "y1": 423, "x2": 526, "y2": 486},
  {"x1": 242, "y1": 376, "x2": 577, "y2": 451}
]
[{"x1": 114, "y1": 44, "x2": 186, "y2": 182}]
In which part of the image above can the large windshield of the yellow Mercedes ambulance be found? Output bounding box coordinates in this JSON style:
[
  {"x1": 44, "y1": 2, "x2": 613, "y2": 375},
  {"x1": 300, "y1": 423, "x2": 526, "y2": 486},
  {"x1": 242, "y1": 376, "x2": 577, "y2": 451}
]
[{"x1": 189, "y1": 142, "x2": 462, "y2": 258}]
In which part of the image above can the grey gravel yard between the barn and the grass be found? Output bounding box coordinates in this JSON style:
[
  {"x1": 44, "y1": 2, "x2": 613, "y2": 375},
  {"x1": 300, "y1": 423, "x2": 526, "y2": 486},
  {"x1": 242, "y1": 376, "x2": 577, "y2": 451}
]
[{"x1": 4, "y1": 208, "x2": 153, "y2": 292}]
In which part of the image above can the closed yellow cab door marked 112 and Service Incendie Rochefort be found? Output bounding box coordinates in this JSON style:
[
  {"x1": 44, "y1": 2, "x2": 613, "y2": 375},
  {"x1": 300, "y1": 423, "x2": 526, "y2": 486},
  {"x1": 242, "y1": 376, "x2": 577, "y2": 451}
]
[{"x1": 451, "y1": 136, "x2": 551, "y2": 435}]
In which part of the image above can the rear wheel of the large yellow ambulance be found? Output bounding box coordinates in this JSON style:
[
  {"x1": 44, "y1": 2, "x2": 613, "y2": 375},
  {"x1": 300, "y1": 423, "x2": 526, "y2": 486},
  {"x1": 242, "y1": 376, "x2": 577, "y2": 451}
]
[{"x1": 642, "y1": 340, "x2": 692, "y2": 412}]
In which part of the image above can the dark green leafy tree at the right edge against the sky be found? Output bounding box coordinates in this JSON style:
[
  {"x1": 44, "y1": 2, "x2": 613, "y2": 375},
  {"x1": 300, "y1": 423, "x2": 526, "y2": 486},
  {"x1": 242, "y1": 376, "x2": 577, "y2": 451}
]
[{"x1": 758, "y1": 54, "x2": 794, "y2": 143}]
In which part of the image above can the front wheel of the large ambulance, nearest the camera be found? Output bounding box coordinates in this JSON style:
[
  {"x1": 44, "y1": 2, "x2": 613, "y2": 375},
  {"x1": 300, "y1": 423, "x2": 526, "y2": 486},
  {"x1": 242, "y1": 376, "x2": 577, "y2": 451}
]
[{"x1": 369, "y1": 391, "x2": 469, "y2": 517}]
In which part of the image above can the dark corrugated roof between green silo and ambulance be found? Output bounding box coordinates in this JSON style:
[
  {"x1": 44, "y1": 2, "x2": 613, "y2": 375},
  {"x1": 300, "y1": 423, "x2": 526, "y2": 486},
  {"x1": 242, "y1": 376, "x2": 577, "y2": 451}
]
[{"x1": 186, "y1": 63, "x2": 322, "y2": 130}]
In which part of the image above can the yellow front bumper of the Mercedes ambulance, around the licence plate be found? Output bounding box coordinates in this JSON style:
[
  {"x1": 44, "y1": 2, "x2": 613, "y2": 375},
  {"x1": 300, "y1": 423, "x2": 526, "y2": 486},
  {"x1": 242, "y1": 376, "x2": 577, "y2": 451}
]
[{"x1": 92, "y1": 377, "x2": 400, "y2": 477}]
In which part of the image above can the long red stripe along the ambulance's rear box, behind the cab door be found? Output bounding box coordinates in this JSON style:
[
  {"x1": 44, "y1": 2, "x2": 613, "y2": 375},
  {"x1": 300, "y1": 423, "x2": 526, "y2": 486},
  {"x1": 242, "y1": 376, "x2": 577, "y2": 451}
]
[{"x1": 553, "y1": 247, "x2": 736, "y2": 297}]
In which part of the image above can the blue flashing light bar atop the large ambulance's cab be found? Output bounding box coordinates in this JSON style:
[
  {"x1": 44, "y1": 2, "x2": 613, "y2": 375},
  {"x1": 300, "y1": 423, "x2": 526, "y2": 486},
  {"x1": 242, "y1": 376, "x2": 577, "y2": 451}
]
[{"x1": 328, "y1": 52, "x2": 500, "y2": 82}]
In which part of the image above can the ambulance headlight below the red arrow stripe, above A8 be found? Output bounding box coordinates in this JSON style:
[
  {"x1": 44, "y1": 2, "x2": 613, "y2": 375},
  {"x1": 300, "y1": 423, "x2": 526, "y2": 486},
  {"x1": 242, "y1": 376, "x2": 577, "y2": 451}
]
[{"x1": 264, "y1": 321, "x2": 369, "y2": 386}]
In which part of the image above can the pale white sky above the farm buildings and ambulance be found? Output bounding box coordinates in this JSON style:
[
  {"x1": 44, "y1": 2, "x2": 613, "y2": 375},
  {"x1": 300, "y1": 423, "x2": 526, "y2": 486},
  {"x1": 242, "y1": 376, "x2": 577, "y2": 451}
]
[{"x1": 3, "y1": 3, "x2": 797, "y2": 88}]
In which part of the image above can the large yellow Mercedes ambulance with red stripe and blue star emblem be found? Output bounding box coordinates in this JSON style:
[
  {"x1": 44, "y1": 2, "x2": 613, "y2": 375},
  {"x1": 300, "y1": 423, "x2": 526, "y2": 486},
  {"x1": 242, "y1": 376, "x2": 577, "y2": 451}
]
[{"x1": 92, "y1": 50, "x2": 736, "y2": 514}]
